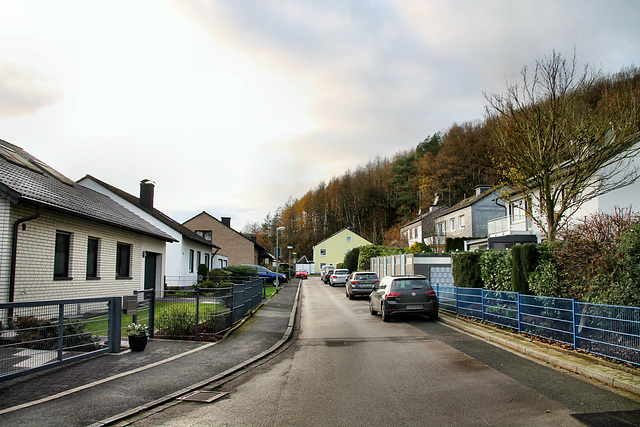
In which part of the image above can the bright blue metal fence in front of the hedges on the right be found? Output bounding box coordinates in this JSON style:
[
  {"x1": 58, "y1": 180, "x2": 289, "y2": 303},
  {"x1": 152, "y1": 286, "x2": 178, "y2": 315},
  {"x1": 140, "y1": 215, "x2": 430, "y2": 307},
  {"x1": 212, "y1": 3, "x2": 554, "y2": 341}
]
[{"x1": 433, "y1": 285, "x2": 640, "y2": 365}]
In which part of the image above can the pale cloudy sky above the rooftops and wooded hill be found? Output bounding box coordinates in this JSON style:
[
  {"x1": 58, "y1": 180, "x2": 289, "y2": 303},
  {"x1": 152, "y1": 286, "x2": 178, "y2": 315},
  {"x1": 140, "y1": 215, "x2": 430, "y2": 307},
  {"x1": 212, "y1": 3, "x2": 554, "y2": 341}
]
[{"x1": 0, "y1": 0, "x2": 640, "y2": 230}]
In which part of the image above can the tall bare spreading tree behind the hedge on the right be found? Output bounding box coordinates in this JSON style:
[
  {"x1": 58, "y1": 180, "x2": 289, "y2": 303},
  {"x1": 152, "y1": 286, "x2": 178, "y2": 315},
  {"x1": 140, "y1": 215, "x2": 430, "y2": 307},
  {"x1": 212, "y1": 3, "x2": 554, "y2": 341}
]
[{"x1": 485, "y1": 51, "x2": 640, "y2": 240}]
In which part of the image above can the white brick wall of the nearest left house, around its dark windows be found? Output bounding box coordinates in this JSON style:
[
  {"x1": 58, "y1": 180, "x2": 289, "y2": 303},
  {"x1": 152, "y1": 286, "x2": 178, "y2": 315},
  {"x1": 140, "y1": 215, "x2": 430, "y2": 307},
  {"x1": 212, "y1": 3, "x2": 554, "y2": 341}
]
[{"x1": 0, "y1": 204, "x2": 166, "y2": 302}]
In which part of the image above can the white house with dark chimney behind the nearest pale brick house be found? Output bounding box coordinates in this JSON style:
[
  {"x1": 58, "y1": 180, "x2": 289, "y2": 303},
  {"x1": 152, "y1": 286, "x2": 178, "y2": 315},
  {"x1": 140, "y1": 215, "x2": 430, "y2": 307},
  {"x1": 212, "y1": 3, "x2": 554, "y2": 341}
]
[{"x1": 78, "y1": 175, "x2": 220, "y2": 286}]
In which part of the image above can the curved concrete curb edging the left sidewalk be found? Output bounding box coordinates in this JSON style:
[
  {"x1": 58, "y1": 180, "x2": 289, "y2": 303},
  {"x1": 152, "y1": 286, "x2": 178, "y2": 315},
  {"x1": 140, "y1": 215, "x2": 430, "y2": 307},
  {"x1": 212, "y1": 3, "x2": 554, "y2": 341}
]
[{"x1": 89, "y1": 285, "x2": 302, "y2": 427}]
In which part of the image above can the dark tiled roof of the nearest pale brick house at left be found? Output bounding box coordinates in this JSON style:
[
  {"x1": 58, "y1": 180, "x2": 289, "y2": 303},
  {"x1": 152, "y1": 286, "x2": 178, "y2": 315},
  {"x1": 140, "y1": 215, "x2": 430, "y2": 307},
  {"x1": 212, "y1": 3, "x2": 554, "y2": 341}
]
[{"x1": 0, "y1": 139, "x2": 175, "y2": 242}]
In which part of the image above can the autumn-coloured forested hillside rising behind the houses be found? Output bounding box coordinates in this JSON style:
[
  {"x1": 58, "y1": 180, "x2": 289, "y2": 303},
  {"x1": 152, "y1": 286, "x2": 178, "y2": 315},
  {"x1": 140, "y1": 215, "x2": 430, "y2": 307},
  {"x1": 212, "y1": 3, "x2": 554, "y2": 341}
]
[{"x1": 243, "y1": 59, "x2": 640, "y2": 260}]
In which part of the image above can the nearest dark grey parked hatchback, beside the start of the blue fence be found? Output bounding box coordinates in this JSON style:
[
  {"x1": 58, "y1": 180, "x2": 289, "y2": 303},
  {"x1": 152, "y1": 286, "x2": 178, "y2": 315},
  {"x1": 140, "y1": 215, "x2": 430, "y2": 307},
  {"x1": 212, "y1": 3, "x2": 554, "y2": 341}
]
[{"x1": 369, "y1": 275, "x2": 438, "y2": 322}]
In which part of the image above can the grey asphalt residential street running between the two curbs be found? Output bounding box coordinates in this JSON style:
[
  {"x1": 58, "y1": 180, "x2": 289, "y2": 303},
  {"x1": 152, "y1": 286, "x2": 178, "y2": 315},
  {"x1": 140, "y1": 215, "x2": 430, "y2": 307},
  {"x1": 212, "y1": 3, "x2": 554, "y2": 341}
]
[{"x1": 127, "y1": 277, "x2": 640, "y2": 426}]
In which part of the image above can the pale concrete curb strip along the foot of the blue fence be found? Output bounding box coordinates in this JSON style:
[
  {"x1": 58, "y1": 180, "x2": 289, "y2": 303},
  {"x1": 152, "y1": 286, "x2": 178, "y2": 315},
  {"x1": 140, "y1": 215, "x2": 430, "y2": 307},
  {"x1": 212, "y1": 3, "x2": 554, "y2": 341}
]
[{"x1": 440, "y1": 312, "x2": 640, "y2": 396}]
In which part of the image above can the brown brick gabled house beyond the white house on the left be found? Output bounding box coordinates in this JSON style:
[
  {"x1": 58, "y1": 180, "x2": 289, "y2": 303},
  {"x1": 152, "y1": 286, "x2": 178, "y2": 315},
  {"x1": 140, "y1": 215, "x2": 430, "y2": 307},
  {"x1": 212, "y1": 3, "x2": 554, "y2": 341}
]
[{"x1": 182, "y1": 211, "x2": 272, "y2": 268}]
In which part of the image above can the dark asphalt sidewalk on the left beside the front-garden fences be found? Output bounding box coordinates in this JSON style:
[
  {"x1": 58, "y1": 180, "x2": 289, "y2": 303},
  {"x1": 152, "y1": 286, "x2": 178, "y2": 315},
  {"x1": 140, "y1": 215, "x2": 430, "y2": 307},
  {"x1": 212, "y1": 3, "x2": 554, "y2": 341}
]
[{"x1": 0, "y1": 280, "x2": 299, "y2": 426}]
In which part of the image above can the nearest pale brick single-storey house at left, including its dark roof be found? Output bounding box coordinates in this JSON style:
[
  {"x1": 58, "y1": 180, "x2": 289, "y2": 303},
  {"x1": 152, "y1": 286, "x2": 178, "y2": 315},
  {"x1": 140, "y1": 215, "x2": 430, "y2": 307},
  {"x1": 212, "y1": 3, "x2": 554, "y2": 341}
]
[{"x1": 0, "y1": 140, "x2": 174, "y2": 302}]
